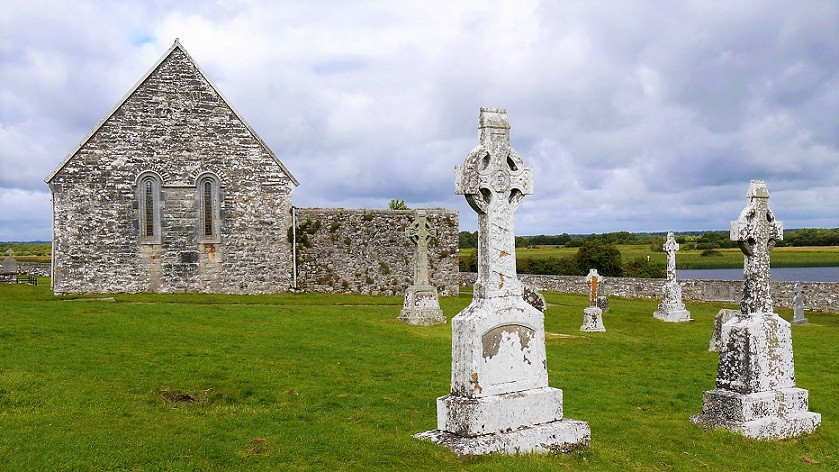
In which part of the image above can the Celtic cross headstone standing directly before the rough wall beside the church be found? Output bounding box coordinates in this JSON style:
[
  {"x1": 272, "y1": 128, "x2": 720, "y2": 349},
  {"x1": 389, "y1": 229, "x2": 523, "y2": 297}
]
[{"x1": 398, "y1": 210, "x2": 446, "y2": 326}]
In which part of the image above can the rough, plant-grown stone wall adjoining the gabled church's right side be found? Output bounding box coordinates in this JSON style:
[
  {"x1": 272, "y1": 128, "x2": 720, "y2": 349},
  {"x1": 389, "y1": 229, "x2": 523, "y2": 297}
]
[{"x1": 296, "y1": 208, "x2": 459, "y2": 296}]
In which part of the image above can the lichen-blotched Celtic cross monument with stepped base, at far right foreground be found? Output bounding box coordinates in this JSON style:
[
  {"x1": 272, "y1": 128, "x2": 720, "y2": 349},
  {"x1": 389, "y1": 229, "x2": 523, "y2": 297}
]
[{"x1": 691, "y1": 180, "x2": 821, "y2": 439}]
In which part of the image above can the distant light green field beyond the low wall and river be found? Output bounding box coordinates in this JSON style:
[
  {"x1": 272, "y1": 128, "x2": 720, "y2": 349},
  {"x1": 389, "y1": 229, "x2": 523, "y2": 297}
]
[{"x1": 460, "y1": 245, "x2": 839, "y2": 269}]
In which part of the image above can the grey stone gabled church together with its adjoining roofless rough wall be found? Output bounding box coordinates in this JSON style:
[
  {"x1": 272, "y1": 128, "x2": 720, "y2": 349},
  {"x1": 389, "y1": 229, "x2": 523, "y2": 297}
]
[{"x1": 45, "y1": 40, "x2": 458, "y2": 295}]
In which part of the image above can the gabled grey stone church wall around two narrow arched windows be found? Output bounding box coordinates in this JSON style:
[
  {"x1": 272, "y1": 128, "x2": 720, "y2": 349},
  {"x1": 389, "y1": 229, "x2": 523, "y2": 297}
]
[{"x1": 50, "y1": 48, "x2": 295, "y2": 293}]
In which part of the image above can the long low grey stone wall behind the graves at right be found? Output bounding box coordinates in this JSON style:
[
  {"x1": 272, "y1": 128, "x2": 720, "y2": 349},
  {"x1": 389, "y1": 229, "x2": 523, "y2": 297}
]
[{"x1": 460, "y1": 272, "x2": 839, "y2": 313}]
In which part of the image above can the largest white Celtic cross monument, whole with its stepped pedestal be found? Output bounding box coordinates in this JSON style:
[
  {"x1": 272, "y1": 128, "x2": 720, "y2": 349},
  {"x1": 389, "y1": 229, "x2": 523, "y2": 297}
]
[{"x1": 416, "y1": 108, "x2": 591, "y2": 456}]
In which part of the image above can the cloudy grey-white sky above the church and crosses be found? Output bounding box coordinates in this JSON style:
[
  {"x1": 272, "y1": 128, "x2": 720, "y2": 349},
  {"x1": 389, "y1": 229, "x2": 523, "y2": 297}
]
[{"x1": 0, "y1": 0, "x2": 839, "y2": 241}]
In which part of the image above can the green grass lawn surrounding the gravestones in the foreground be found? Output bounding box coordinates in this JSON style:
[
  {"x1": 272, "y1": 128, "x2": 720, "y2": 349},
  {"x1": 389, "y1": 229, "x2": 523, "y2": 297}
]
[{"x1": 0, "y1": 279, "x2": 839, "y2": 471}]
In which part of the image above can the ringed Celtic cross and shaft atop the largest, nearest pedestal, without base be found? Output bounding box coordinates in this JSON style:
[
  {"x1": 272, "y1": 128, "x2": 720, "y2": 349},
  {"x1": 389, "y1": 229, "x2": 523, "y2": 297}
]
[{"x1": 455, "y1": 107, "x2": 533, "y2": 298}]
